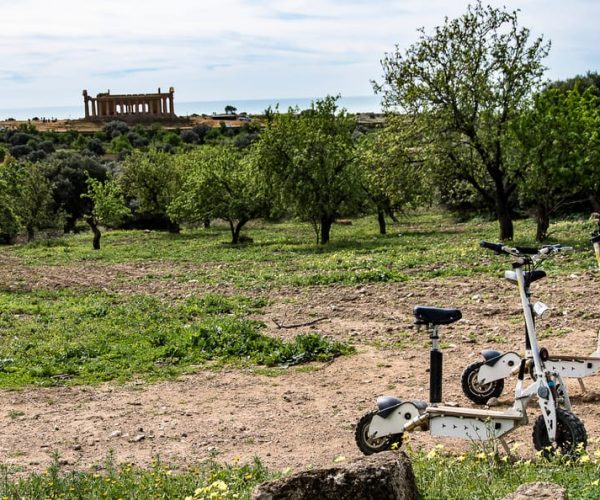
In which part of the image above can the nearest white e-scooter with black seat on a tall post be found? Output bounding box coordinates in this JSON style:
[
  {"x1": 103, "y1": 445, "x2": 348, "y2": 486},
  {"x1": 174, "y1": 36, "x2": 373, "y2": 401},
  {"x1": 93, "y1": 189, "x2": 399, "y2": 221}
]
[{"x1": 355, "y1": 247, "x2": 587, "y2": 455}]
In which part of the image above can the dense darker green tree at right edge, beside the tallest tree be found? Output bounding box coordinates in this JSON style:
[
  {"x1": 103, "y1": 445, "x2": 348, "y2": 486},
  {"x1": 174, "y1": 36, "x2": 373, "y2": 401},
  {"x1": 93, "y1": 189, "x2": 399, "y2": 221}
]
[{"x1": 514, "y1": 86, "x2": 600, "y2": 241}]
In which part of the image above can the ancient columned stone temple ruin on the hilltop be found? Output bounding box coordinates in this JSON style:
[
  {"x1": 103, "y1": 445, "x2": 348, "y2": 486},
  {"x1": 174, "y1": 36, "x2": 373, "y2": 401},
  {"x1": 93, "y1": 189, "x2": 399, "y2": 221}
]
[{"x1": 83, "y1": 87, "x2": 175, "y2": 120}]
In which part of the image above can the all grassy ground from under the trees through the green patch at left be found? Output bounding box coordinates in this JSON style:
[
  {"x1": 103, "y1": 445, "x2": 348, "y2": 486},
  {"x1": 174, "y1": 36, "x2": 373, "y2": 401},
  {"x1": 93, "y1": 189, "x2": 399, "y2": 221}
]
[{"x1": 0, "y1": 212, "x2": 595, "y2": 388}]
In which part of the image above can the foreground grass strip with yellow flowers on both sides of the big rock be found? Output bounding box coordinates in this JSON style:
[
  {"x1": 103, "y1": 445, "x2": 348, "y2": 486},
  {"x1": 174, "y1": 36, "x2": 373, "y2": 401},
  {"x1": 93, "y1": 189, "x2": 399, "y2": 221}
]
[{"x1": 0, "y1": 445, "x2": 600, "y2": 500}]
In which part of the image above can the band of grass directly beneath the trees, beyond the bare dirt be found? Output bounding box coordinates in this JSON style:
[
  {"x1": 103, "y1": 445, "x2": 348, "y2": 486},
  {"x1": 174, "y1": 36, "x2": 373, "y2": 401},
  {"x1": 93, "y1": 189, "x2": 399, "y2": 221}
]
[{"x1": 0, "y1": 211, "x2": 596, "y2": 288}]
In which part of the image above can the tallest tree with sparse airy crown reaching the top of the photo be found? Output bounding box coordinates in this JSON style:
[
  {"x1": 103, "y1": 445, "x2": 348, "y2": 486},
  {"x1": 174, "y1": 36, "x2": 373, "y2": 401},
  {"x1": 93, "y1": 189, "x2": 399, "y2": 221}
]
[{"x1": 375, "y1": 1, "x2": 549, "y2": 240}]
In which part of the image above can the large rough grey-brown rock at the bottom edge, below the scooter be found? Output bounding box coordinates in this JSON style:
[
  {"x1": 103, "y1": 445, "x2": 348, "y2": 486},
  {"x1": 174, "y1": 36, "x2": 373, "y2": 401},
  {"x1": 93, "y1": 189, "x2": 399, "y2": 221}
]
[{"x1": 252, "y1": 451, "x2": 418, "y2": 500}]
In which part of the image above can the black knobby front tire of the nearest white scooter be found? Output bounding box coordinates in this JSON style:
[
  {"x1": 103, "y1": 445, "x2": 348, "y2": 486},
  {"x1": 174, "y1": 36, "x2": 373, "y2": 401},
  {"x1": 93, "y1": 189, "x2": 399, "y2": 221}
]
[{"x1": 533, "y1": 408, "x2": 587, "y2": 458}]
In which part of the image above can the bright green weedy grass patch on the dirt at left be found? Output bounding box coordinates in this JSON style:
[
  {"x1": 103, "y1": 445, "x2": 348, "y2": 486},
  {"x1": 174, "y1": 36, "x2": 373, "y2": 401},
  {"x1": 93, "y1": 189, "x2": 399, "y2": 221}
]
[{"x1": 0, "y1": 289, "x2": 352, "y2": 388}]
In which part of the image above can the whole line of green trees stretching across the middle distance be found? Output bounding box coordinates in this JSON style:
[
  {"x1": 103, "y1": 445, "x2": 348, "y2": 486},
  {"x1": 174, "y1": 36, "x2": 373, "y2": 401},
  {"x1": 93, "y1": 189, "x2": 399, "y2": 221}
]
[{"x1": 0, "y1": 2, "x2": 600, "y2": 247}]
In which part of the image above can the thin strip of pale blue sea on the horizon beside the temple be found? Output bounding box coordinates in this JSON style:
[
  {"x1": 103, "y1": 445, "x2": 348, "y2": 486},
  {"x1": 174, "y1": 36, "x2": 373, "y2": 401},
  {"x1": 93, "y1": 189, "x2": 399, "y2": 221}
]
[{"x1": 0, "y1": 95, "x2": 381, "y2": 120}]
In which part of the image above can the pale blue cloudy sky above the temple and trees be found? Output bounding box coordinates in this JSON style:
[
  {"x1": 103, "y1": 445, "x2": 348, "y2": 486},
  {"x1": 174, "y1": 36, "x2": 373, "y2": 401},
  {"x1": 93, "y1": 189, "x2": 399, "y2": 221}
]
[{"x1": 0, "y1": 0, "x2": 600, "y2": 109}]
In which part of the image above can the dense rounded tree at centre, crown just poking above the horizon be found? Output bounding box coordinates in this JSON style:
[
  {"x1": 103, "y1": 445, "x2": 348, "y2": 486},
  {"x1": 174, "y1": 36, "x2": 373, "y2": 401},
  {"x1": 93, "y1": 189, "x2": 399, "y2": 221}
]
[{"x1": 255, "y1": 96, "x2": 362, "y2": 244}]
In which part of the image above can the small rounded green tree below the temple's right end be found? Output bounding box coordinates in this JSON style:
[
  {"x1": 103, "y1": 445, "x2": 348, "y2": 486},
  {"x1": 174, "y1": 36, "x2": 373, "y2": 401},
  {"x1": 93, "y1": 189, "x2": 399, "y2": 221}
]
[{"x1": 119, "y1": 149, "x2": 183, "y2": 232}]
